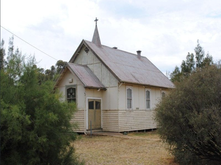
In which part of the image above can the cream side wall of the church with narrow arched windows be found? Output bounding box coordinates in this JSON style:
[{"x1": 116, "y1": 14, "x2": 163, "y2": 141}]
[{"x1": 119, "y1": 84, "x2": 167, "y2": 132}]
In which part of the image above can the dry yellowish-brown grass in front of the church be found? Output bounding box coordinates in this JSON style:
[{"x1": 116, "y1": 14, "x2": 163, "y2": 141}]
[{"x1": 74, "y1": 132, "x2": 175, "y2": 165}]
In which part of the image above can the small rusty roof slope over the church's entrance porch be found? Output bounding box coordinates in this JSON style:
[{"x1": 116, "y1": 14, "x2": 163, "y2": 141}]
[{"x1": 67, "y1": 63, "x2": 106, "y2": 89}]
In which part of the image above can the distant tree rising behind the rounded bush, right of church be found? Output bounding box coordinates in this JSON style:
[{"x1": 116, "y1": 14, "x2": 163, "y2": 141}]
[{"x1": 170, "y1": 41, "x2": 213, "y2": 83}]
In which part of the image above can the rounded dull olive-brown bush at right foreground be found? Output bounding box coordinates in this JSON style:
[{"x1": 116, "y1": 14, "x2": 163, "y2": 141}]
[{"x1": 156, "y1": 65, "x2": 221, "y2": 164}]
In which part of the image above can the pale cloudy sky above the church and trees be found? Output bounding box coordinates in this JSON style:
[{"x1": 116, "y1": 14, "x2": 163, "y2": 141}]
[{"x1": 1, "y1": 0, "x2": 221, "y2": 73}]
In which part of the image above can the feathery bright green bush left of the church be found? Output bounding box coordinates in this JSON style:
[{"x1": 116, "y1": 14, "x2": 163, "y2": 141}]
[{"x1": 0, "y1": 37, "x2": 83, "y2": 165}]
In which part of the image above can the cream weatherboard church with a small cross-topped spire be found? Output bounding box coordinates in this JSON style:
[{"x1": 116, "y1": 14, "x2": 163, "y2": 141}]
[{"x1": 56, "y1": 19, "x2": 174, "y2": 132}]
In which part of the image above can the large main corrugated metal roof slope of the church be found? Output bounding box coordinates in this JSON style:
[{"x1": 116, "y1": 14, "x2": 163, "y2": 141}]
[{"x1": 83, "y1": 40, "x2": 174, "y2": 88}]
